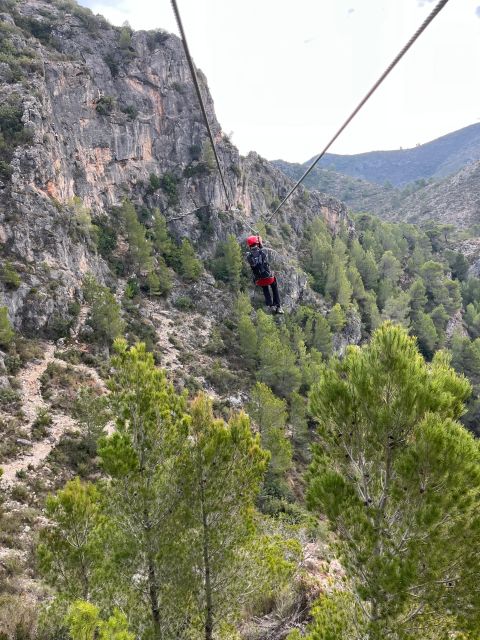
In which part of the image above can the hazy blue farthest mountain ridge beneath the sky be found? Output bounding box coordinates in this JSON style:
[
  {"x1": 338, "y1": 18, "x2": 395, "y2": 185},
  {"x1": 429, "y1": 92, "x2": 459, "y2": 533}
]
[{"x1": 273, "y1": 124, "x2": 480, "y2": 190}]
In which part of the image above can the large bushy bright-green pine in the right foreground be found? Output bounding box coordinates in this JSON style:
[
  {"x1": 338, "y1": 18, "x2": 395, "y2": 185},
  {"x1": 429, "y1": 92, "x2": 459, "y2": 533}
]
[{"x1": 308, "y1": 324, "x2": 480, "y2": 640}]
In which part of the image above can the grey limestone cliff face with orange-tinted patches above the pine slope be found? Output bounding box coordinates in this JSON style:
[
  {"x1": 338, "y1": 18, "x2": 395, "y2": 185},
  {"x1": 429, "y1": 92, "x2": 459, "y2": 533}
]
[{"x1": 0, "y1": 0, "x2": 352, "y2": 333}]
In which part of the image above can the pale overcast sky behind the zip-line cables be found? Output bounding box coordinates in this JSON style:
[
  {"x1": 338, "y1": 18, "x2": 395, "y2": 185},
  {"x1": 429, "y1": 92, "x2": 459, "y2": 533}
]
[{"x1": 80, "y1": 0, "x2": 480, "y2": 162}]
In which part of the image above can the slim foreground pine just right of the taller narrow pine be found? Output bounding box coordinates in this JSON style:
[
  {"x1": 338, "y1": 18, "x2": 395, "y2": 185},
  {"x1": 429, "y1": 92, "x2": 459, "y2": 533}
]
[{"x1": 178, "y1": 395, "x2": 268, "y2": 640}]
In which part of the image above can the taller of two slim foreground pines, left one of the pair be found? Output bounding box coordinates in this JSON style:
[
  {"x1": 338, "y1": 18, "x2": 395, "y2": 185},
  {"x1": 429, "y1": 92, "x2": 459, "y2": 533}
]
[{"x1": 99, "y1": 340, "x2": 188, "y2": 640}]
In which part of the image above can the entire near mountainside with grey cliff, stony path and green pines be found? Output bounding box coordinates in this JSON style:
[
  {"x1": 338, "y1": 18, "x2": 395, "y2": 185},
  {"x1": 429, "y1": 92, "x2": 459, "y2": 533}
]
[{"x1": 0, "y1": 0, "x2": 480, "y2": 640}]
